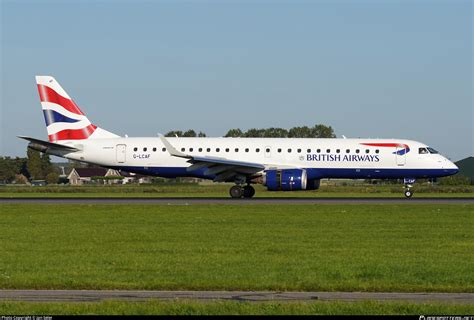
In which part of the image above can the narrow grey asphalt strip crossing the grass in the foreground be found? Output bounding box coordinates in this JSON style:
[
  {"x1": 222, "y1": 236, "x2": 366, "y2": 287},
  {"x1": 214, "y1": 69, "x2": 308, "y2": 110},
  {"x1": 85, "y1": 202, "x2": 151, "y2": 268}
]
[{"x1": 0, "y1": 290, "x2": 474, "y2": 304}]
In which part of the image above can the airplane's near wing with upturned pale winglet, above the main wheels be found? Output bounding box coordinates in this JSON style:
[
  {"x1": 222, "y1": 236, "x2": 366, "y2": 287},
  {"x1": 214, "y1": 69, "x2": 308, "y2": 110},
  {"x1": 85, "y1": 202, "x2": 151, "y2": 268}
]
[{"x1": 160, "y1": 135, "x2": 265, "y2": 182}]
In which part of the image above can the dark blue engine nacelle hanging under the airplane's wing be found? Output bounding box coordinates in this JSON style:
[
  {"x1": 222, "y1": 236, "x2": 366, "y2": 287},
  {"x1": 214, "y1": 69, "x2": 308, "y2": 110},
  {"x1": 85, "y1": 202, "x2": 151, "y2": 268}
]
[{"x1": 264, "y1": 169, "x2": 307, "y2": 191}]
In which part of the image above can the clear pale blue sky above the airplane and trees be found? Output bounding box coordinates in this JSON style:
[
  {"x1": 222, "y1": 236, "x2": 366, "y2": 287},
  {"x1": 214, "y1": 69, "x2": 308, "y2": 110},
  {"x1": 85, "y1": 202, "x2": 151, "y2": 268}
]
[{"x1": 0, "y1": 0, "x2": 474, "y2": 160}]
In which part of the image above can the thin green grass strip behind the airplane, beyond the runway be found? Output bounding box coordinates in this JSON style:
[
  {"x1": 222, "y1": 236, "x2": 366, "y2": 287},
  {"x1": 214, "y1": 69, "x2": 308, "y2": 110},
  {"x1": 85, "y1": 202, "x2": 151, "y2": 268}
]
[{"x1": 0, "y1": 183, "x2": 474, "y2": 198}]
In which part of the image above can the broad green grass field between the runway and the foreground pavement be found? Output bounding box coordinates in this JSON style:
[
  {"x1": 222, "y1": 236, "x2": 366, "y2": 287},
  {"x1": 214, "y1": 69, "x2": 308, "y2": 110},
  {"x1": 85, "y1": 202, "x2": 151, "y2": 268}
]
[{"x1": 0, "y1": 204, "x2": 474, "y2": 292}]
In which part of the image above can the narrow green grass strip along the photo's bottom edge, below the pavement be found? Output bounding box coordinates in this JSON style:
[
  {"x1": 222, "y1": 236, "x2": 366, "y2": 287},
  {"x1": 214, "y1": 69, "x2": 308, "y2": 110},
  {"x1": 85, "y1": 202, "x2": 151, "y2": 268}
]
[{"x1": 0, "y1": 300, "x2": 474, "y2": 315}]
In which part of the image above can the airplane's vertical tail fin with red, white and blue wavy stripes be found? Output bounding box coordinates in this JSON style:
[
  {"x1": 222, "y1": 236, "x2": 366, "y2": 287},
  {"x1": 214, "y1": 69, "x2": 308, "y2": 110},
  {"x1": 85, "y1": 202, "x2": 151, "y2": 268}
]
[{"x1": 36, "y1": 76, "x2": 118, "y2": 143}]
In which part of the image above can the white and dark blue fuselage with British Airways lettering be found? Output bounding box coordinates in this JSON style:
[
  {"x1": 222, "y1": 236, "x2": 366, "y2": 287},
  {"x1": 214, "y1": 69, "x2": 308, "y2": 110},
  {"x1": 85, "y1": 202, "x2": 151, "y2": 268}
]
[{"x1": 52, "y1": 137, "x2": 458, "y2": 179}]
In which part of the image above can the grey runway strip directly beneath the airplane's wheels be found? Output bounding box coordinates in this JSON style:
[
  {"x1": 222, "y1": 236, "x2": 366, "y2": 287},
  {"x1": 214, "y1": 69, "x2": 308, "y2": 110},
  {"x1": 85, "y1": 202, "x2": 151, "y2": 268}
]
[{"x1": 0, "y1": 197, "x2": 474, "y2": 205}]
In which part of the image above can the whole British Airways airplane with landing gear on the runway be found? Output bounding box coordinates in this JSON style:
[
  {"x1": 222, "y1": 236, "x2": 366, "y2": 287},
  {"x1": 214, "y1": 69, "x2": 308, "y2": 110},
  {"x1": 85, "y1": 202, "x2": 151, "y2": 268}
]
[{"x1": 19, "y1": 76, "x2": 459, "y2": 198}]
